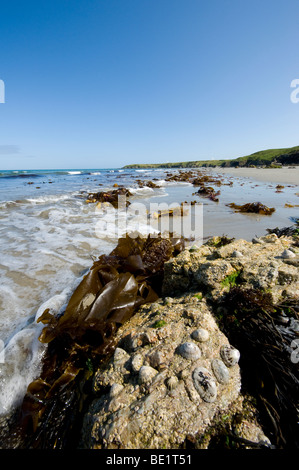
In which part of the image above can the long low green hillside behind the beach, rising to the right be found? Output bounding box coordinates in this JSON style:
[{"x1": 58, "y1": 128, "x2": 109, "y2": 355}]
[{"x1": 123, "y1": 146, "x2": 299, "y2": 168}]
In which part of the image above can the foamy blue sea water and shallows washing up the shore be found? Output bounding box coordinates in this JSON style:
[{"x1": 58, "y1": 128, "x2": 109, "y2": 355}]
[{"x1": 0, "y1": 165, "x2": 299, "y2": 416}]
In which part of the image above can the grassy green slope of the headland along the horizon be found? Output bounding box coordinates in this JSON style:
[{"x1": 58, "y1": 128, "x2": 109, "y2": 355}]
[{"x1": 124, "y1": 146, "x2": 299, "y2": 168}]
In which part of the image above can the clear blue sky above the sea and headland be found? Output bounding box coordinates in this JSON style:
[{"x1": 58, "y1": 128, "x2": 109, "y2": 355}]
[{"x1": 0, "y1": 0, "x2": 299, "y2": 169}]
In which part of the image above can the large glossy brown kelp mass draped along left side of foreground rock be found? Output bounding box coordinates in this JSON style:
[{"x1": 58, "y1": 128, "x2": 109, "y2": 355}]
[{"x1": 21, "y1": 235, "x2": 184, "y2": 449}]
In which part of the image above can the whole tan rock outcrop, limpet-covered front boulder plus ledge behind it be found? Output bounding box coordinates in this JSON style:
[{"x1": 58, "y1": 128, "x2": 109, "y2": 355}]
[{"x1": 80, "y1": 233, "x2": 299, "y2": 449}]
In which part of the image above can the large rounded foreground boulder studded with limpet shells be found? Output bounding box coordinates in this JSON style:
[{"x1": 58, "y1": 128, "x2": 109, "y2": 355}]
[{"x1": 81, "y1": 295, "x2": 241, "y2": 449}]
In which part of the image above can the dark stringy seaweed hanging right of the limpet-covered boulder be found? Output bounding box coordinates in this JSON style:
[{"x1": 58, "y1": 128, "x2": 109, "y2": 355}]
[{"x1": 217, "y1": 286, "x2": 299, "y2": 448}]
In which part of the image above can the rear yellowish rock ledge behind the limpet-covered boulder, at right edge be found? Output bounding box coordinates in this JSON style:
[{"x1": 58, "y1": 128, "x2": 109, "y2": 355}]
[{"x1": 163, "y1": 233, "x2": 299, "y2": 302}]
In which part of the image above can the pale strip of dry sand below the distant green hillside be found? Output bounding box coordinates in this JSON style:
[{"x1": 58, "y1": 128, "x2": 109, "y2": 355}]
[{"x1": 209, "y1": 166, "x2": 299, "y2": 184}]
